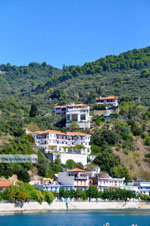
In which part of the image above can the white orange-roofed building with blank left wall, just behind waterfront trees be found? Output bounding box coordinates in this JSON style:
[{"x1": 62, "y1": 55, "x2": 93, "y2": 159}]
[{"x1": 58, "y1": 168, "x2": 89, "y2": 188}]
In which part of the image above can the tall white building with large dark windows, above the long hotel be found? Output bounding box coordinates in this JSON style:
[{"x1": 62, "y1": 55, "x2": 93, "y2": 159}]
[{"x1": 66, "y1": 104, "x2": 90, "y2": 129}]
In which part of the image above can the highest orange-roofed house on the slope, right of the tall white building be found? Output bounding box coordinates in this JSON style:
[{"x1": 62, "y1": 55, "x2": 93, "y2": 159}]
[{"x1": 96, "y1": 96, "x2": 118, "y2": 107}]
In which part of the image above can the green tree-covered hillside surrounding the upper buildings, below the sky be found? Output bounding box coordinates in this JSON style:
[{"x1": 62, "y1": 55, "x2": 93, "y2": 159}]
[{"x1": 0, "y1": 47, "x2": 150, "y2": 181}]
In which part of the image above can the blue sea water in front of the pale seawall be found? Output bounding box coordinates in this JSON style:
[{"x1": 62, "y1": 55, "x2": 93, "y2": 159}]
[{"x1": 0, "y1": 210, "x2": 150, "y2": 226}]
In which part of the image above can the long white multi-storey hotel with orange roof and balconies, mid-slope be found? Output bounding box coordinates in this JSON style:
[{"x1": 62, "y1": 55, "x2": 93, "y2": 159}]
[{"x1": 30, "y1": 130, "x2": 91, "y2": 155}]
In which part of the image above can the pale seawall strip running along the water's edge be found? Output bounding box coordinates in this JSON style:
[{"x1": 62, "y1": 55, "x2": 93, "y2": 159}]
[{"x1": 0, "y1": 201, "x2": 150, "y2": 216}]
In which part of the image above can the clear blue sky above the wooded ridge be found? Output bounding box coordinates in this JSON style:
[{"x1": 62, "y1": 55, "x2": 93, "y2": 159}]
[{"x1": 0, "y1": 0, "x2": 150, "y2": 68}]
